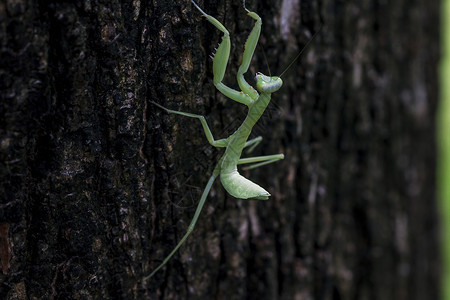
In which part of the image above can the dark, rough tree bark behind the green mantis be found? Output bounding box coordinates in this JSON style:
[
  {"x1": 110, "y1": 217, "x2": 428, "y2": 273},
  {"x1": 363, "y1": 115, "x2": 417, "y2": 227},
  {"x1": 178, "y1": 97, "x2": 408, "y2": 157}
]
[{"x1": 0, "y1": 0, "x2": 440, "y2": 299}]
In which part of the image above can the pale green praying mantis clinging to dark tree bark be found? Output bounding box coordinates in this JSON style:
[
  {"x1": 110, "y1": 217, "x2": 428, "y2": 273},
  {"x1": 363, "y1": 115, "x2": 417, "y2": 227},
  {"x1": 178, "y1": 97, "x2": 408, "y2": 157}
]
[{"x1": 144, "y1": 0, "x2": 317, "y2": 280}]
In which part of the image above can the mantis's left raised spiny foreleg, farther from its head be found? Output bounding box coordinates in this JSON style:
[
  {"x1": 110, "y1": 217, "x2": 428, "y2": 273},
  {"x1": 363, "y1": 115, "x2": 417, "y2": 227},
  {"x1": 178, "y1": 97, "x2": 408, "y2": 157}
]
[{"x1": 191, "y1": 0, "x2": 253, "y2": 106}]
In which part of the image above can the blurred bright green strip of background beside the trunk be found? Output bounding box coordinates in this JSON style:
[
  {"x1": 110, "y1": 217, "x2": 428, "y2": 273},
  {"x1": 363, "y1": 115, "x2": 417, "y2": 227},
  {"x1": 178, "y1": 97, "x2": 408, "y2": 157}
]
[{"x1": 437, "y1": 0, "x2": 450, "y2": 300}]
